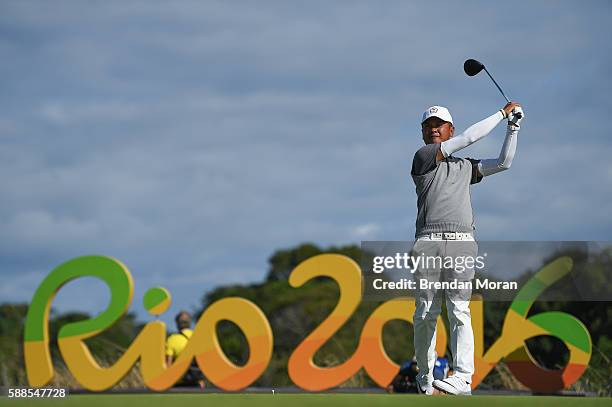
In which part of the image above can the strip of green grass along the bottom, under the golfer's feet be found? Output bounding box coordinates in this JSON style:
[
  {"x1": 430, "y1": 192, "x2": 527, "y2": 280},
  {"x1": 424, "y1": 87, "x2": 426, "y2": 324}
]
[{"x1": 0, "y1": 393, "x2": 611, "y2": 407}]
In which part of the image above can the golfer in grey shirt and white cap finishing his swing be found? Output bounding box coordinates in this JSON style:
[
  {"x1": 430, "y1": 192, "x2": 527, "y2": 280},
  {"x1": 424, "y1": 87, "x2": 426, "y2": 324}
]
[{"x1": 411, "y1": 102, "x2": 523, "y2": 395}]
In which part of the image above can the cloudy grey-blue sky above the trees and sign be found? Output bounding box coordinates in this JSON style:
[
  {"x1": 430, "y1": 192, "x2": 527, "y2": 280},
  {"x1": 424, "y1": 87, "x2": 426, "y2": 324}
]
[{"x1": 0, "y1": 1, "x2": 612, "y2": 326}]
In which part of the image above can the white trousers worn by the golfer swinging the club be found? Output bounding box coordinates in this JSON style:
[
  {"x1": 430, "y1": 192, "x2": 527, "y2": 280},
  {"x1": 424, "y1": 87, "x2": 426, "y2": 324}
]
[{"x1": 413, "y1": 237, "x2": 478, "y2": 387}]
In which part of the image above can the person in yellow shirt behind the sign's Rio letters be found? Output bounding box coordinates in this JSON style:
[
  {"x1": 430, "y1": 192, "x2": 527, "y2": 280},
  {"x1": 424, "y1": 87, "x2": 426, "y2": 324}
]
[{"x1": 166, "y1": 311, "x2": 204, "y2": 389}]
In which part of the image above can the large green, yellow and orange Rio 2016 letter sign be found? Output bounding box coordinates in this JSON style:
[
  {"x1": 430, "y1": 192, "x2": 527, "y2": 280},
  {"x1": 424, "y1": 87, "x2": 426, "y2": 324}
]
[{"x1": 24, "y1": 254, "x2": 591, "y2": 392}]
